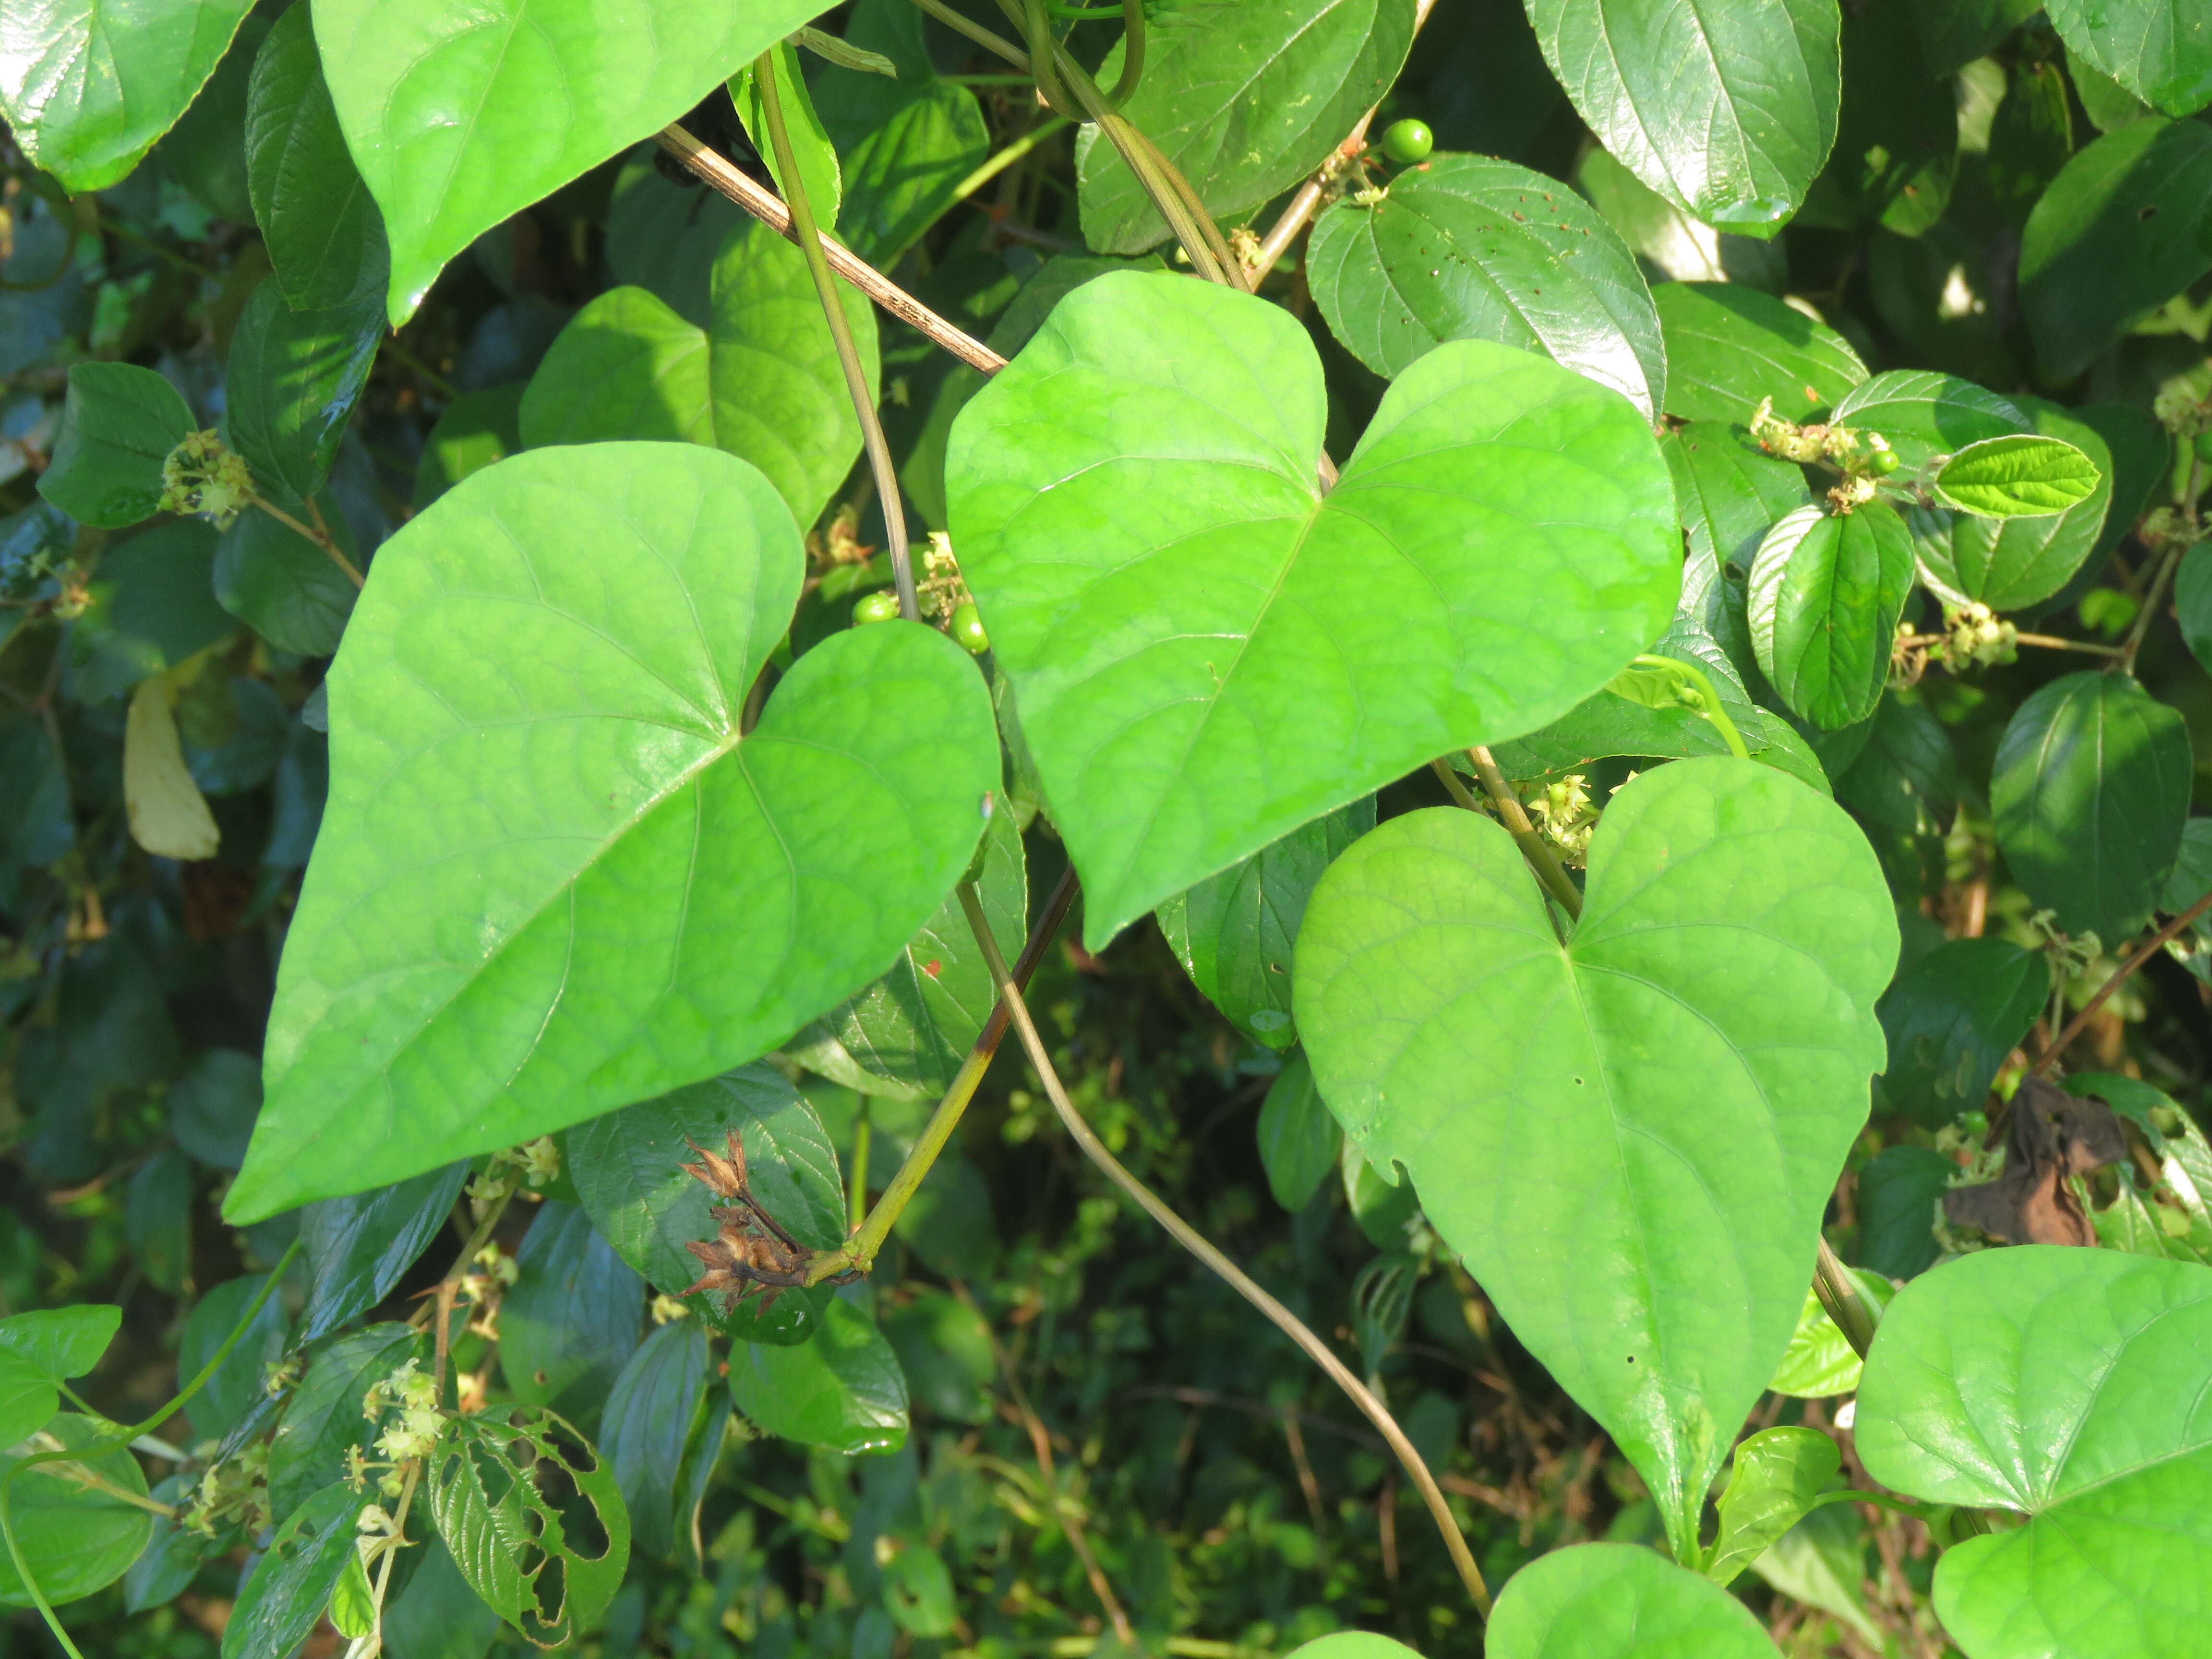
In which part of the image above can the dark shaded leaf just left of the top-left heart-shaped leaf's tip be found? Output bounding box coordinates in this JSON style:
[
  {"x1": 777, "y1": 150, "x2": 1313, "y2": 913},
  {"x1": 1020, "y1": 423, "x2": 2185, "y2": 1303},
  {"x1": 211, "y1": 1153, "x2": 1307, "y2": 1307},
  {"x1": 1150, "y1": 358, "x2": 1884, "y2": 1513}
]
[{"x1": 223, "y1": 279, "x2": 385, "y2": 502}]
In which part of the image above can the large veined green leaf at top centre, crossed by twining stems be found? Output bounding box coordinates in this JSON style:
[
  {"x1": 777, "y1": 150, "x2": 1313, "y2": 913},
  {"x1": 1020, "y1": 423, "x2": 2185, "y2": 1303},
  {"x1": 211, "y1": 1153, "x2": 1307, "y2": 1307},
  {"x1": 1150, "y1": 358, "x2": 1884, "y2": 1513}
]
[{"x1": 1077, "y1": 0, "x2": 1414, "y2": 254}]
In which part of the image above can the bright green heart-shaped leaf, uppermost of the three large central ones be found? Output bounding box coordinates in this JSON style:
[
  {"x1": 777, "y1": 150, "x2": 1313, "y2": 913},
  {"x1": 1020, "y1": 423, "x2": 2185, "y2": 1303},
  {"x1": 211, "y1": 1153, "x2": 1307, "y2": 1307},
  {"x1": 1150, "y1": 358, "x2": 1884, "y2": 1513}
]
[{"x1": 947, "y1": 272, "x2": 1681, "y2": 949}]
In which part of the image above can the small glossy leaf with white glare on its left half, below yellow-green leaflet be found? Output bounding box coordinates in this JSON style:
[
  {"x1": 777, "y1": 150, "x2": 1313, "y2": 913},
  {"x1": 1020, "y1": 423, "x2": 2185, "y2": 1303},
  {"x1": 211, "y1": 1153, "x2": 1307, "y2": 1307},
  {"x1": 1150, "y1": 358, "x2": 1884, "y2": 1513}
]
[{"x1": 1747, "y1": 502, "x2": 1913, "y2": 732}]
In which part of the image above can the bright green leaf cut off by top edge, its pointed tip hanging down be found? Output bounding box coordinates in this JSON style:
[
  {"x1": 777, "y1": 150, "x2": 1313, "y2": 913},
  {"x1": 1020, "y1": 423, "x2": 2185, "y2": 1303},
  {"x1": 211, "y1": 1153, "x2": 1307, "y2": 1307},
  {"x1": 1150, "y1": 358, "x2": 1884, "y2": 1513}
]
[{"x1": 310, "y1": 0, "x2": 823, "y2": 327}]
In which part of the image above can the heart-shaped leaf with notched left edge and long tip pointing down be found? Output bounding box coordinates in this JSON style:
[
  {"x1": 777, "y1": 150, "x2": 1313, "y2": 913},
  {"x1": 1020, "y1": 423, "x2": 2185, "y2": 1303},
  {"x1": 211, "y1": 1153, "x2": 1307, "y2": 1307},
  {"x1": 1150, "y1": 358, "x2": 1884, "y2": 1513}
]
[{"x1": 1296, "y1": 759, "x2": 1898, "y2": 1560}]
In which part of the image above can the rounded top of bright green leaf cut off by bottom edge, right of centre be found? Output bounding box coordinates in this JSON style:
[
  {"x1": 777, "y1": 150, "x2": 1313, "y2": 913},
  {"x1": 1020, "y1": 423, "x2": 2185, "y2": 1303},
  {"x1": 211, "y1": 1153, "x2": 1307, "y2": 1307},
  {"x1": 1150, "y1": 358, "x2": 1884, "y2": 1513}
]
[{"x1": 1482, "y1": 1544, "x2": 1774, "y2": 1659}]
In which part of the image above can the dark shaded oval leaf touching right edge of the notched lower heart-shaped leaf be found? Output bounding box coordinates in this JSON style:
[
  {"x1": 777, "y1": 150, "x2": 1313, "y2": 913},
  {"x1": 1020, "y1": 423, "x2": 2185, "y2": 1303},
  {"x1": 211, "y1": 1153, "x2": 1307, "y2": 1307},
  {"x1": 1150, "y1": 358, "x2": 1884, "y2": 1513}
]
[{"x1": 1880, "y1": 938, "x2": 2051, "y2": 1128}]
